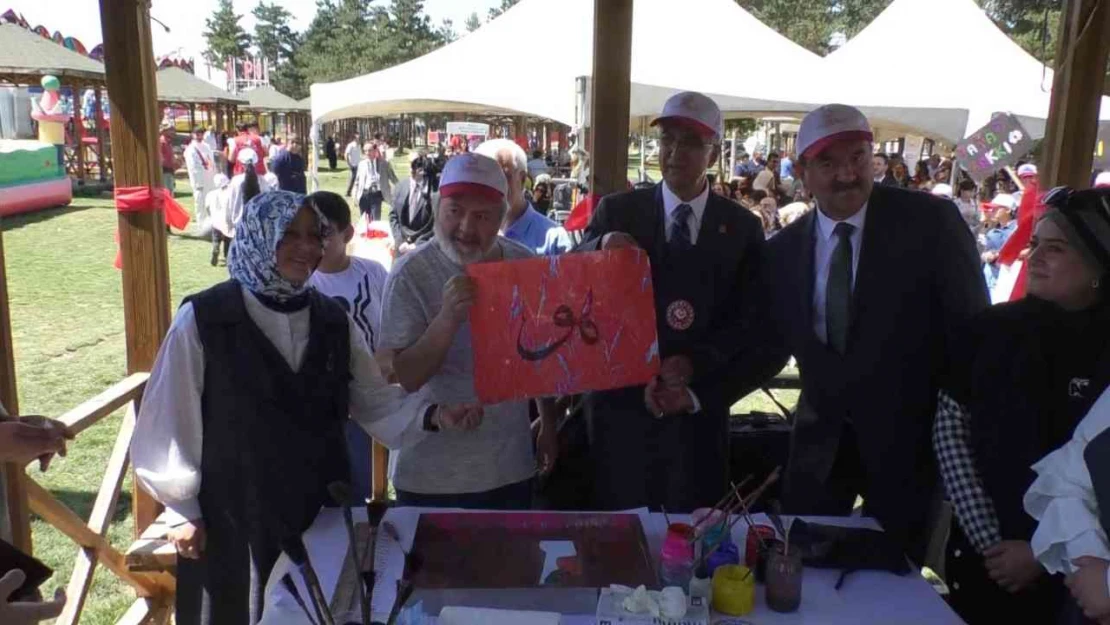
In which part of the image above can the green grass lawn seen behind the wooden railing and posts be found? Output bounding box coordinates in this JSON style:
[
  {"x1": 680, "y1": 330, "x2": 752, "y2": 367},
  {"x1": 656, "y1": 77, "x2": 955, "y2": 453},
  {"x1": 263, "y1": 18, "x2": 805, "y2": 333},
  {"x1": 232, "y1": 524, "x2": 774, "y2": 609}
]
[{"x1": 2, "y1": 157, "x2": 796, "y2": 625}]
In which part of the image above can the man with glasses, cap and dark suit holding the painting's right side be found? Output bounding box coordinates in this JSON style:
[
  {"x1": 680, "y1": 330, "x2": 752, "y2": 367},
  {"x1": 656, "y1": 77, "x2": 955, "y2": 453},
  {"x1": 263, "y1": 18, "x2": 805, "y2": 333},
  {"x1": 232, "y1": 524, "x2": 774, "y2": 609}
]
[{"x1": 578, "y1": 92, "x2": 773, "y2": 512}]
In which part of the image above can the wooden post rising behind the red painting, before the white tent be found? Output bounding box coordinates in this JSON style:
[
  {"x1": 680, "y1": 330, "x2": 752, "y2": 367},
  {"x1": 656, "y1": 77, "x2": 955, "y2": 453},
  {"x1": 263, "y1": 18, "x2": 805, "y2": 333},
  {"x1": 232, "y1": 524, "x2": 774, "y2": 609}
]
[{"x1": 589, "y1": 0, "x2": 633, "y2": 195}]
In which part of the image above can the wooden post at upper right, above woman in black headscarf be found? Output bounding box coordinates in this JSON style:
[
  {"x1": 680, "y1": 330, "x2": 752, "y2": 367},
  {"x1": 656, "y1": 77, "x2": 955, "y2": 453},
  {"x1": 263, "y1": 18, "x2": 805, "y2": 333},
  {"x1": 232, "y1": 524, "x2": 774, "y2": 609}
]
[{"x1": 1040, "y1": 0, "x2": 1110, "y2": 189}]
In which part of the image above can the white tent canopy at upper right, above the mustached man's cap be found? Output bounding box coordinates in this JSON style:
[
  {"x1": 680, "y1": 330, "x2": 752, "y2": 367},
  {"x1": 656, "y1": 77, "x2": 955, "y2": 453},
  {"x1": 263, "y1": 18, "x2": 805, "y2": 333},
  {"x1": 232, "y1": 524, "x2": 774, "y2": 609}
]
[{"x1": 818, "y1": 0, "x2": 1110, "y2": 143}]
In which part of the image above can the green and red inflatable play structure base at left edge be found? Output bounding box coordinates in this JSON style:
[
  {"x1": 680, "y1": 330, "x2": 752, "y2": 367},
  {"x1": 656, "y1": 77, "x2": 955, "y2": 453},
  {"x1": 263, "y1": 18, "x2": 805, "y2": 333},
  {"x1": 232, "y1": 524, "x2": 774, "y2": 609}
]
[{"x1": 0, "y1": 140, "x2": 73, "y2": 216}]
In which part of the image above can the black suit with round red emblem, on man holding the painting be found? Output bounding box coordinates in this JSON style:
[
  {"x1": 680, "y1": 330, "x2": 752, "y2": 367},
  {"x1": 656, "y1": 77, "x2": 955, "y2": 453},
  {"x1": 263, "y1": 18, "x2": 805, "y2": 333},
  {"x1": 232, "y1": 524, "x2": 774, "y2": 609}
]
[{"x1": 578, "y1": 185, "x2": 766, "y2": 512}]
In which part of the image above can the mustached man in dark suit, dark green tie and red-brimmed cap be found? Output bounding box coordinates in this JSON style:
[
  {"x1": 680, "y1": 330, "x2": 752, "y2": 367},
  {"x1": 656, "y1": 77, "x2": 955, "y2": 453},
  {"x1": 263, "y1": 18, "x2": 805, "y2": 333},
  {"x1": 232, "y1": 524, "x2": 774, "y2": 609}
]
[{"x1": 739, "y1": 104, "x2": 987, "y2": 562}]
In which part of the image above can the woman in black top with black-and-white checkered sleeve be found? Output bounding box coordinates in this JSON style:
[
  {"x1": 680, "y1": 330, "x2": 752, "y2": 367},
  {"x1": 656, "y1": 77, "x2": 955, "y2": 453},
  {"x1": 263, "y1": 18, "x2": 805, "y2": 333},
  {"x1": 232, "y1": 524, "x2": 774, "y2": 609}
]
[{"x1": 934, "y1": 190, "x2": 1110, "y2": 625}]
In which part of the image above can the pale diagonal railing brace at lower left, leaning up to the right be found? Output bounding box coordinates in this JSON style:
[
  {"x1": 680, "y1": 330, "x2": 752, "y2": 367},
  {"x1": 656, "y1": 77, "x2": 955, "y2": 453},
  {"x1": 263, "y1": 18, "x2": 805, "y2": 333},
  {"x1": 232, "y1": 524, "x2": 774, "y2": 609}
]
[{"x1": 54, "y1": 403, "x2": 135, "y2": 625}]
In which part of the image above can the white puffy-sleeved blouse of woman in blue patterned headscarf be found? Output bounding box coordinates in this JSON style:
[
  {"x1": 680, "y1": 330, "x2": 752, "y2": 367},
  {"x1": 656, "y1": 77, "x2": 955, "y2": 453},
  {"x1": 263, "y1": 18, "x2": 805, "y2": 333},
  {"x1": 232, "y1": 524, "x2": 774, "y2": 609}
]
[{"x1": 131, "y1": 289, "x2": 431, "y2": 524}]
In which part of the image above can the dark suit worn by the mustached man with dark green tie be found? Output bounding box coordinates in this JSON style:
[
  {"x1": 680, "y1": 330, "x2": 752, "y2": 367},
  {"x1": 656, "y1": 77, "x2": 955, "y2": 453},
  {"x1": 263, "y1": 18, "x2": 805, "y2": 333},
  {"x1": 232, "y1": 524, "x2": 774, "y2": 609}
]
[{"x1": 750, "y1": 185, "x2": 988, "y2": 555}]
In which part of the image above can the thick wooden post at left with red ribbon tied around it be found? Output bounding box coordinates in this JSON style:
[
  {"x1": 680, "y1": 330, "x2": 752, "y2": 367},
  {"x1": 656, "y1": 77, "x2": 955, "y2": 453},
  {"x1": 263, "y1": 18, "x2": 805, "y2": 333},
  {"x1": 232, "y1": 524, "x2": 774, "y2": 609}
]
[{"x1": 100, "y1": 0, "x2": 170, "y2": 536}]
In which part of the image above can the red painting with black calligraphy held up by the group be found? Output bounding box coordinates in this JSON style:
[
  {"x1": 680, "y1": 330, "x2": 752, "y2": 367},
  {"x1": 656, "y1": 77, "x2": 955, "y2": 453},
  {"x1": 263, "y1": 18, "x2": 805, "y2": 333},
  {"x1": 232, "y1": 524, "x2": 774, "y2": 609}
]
[{"x1": 466, "y1": 250, "x2": 659, "y2": 404}]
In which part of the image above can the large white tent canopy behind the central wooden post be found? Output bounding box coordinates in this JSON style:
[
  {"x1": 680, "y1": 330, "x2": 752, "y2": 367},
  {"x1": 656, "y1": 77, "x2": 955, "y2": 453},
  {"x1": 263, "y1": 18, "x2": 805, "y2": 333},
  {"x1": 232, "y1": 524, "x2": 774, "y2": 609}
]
[{"x1": 312, "y1": 0, "x2": 823, "y2": 125}]
